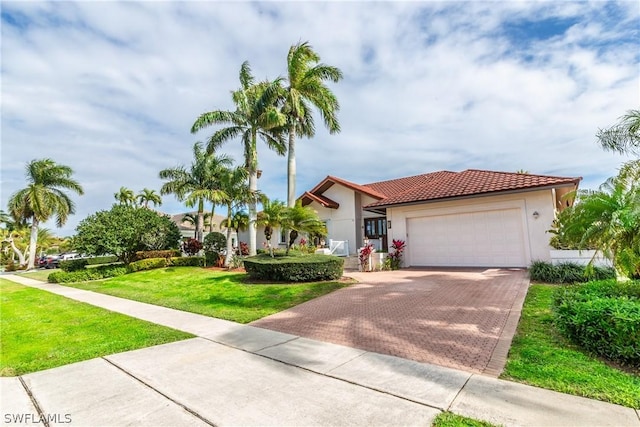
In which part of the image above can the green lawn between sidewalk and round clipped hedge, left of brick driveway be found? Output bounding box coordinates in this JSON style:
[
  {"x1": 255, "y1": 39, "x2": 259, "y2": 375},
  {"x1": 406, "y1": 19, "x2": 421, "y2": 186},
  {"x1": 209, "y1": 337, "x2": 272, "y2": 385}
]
[{"x1": 67, "y1": 267, "x2": 347, "y2": 323}]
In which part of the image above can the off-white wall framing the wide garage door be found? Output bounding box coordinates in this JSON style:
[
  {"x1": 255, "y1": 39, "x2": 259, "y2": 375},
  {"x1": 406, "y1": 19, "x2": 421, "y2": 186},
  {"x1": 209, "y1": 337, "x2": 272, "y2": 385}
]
[{"x1": 387, "y1": 189, "x2": 555, "y2": 267}]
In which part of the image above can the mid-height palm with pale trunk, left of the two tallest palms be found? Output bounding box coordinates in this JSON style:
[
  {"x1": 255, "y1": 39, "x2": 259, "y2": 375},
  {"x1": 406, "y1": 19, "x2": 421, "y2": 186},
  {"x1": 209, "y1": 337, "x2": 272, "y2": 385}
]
[{"x1": 159, "y1": 142, "x2": 232, "y2": 242}]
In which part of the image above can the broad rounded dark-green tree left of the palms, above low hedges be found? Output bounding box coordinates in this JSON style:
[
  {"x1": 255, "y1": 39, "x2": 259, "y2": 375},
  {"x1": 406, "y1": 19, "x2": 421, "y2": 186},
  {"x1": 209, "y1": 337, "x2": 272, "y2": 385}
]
[{"x1": 74, "y1": 205, "x2": 181, "y2": 264}]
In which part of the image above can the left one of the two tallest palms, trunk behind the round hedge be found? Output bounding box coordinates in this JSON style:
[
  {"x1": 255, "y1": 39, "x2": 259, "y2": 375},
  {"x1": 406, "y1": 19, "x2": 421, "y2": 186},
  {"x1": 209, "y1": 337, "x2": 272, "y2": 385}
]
[{"x1": 191, "y1": 61, "x2": 286, "y2": 255}]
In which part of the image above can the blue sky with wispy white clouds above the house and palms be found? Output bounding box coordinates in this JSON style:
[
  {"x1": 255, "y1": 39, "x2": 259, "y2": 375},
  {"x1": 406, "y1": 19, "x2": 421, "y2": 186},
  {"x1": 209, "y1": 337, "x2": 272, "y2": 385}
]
[{"x1": 0, "y1": 1, "x2": 640, "y2": 235}]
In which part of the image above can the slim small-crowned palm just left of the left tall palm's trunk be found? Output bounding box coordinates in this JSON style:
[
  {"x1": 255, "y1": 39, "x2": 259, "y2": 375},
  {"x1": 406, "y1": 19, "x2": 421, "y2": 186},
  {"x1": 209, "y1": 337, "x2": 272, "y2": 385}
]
[{"x1": 220, "y1": 167, "x2": 254, "y2": 267}]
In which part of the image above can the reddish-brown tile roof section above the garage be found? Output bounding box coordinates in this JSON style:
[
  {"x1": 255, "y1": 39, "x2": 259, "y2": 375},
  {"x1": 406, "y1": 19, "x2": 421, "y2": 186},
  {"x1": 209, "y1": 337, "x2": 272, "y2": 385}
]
[{"x1": 365, "y1": 169, "x2": 582, "y2": 208}]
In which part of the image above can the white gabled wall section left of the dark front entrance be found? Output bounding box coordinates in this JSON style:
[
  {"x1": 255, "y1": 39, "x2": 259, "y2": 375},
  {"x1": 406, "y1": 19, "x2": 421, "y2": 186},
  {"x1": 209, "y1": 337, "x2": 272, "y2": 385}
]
[{"x1": 309, "y1": 184, "x2": 360, "y2": 255}]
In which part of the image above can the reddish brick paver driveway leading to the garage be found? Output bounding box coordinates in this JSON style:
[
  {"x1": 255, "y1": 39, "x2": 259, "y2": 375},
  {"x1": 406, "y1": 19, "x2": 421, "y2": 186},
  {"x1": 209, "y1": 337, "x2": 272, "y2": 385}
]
[{"x1": 252, "y1": 269, "x2": 529, "y2": 376}]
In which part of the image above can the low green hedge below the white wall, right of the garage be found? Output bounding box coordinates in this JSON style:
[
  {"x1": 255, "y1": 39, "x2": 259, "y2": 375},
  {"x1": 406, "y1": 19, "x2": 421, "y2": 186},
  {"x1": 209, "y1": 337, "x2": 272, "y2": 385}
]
[{"x1": 529, "y1": 261, "x2": 616, "y2": 283}]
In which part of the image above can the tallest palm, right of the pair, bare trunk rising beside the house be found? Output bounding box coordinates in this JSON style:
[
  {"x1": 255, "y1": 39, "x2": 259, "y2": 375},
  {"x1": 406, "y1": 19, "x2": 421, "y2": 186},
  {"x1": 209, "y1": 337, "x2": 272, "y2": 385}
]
[{"x1": 274, "y1": 42, "x2": 342, "y2": 207}]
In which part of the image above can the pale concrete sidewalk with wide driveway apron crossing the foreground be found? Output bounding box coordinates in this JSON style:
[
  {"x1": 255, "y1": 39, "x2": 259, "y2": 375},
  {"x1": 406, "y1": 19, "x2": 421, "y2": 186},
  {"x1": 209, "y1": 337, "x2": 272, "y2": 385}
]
[{"x1": 0, "y1": 275, "x2": 640, "y2": 426}]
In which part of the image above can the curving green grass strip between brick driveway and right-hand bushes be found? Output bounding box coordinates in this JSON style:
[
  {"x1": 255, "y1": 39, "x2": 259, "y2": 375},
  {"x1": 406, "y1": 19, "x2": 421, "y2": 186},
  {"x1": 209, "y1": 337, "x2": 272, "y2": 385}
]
[{"x1": 501, "y1": 284, "x2": 640, "y2": 409}]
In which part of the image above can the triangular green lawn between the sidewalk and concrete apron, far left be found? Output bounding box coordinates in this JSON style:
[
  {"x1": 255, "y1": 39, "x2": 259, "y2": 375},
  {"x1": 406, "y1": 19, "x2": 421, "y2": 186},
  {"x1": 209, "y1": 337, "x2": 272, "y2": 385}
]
[{"x1": 0, "y1": 279, "x2": 192, "y2": 376}]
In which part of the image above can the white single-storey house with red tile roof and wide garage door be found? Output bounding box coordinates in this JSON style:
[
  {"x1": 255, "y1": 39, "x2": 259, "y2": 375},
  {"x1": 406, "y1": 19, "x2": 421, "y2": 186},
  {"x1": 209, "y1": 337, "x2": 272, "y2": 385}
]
[{"x1": 298, "y1": 169, "x2": 582, "y2": 267}]
